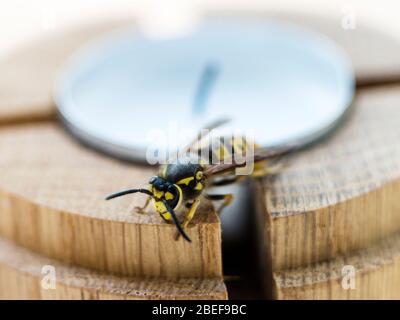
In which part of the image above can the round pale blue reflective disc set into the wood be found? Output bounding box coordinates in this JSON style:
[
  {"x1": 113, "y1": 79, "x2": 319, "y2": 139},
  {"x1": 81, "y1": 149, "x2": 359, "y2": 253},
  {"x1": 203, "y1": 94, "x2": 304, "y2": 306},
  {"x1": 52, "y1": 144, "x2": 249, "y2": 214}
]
[{"x1": 55, "y1": 18, "x2": 354, "y2": 161}]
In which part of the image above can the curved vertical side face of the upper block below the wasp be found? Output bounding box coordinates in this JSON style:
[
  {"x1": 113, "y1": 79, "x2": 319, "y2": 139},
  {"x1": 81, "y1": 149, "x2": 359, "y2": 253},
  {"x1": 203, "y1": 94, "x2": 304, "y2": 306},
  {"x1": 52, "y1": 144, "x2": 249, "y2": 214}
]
[{"x1": 0, "y1": 186, "x2": 222, "y2": 278}]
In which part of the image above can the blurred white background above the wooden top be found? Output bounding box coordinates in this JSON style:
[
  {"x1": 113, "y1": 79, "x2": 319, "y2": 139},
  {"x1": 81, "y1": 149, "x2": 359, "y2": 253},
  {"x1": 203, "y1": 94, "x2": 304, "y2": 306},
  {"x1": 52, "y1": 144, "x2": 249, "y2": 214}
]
[{"x1": 0, "y1": 0, "x2": 400, "y2": 55}]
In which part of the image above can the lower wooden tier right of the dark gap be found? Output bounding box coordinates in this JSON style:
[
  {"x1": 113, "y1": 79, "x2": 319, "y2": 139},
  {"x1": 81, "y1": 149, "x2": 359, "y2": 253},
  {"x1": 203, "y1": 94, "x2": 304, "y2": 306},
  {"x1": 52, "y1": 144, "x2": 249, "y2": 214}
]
[{"x1": 273, "y1": 233, "x2": 400, "y2": 300}]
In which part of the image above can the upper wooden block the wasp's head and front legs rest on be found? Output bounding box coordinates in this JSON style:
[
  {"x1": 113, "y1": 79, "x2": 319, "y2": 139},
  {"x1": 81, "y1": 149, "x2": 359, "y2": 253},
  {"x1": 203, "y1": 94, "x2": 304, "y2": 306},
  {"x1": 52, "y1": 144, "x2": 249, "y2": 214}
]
[{"x1": 0, "y1": 123, "x2": 222, "y2": 278}]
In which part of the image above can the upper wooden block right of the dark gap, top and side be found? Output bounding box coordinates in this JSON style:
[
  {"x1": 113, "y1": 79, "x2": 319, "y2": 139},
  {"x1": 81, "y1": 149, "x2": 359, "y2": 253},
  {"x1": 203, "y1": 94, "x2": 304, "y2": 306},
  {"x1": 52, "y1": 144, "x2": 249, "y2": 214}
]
[{"x1": 257, "y1": 86, "x2": 400, "y2": 271}]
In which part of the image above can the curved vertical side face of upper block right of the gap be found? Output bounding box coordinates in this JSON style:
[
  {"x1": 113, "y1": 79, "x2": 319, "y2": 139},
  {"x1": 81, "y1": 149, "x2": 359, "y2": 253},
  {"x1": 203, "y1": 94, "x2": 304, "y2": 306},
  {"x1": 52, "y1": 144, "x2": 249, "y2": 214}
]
[{"x1": 266, "y1": 180, "x2": 400, "y2": 270}]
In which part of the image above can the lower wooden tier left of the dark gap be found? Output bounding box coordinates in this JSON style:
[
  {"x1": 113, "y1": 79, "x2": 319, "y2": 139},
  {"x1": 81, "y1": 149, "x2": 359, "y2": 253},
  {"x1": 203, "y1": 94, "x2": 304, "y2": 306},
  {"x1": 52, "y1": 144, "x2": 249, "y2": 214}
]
[{"x1": 0, "y1": 239, "x2": 227, "y2": 300}]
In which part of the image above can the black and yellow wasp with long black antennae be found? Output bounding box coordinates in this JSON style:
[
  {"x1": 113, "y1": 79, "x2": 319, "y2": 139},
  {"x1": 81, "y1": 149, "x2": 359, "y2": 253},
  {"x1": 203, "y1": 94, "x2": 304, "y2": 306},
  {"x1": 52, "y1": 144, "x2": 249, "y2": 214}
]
[{"x1": 106, "y1": 121, "x2": 293, "y2": 242}]
